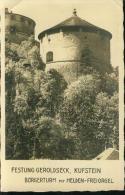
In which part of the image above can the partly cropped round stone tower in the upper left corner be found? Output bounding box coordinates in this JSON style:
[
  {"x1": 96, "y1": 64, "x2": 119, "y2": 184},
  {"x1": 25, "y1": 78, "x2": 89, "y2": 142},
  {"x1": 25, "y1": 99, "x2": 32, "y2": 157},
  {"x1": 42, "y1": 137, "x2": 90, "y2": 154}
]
[{"x1": 5, "y1": 8, "x2": 36, "y2": 44}]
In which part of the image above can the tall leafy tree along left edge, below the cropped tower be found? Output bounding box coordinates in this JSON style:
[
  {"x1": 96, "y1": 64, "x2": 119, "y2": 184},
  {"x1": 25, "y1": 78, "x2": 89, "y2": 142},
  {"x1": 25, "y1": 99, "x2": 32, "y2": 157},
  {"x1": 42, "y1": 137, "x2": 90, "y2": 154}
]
[{"x1": 5, "y1": 38, "x2": 43, "y2": 159}]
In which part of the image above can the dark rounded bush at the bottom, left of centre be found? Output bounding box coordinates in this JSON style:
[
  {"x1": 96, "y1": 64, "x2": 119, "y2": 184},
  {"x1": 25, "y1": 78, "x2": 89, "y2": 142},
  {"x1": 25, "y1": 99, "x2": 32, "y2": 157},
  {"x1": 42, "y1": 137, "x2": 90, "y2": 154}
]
[{"x1": 33, "y1": 117, "x2": 72, "y2": 159}]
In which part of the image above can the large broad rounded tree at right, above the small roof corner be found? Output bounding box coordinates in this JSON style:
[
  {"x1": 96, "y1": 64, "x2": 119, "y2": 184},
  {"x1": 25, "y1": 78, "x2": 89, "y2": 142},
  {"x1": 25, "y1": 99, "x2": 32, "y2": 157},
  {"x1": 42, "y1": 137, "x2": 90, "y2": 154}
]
[{"x1": 59, "y1": 74, "x2": 118, "y2": 159}]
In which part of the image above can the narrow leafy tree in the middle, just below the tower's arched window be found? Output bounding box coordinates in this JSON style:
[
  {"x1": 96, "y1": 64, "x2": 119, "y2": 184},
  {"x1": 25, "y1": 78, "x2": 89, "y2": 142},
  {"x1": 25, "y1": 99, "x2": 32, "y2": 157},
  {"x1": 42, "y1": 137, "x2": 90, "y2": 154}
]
[{"x1": 36, "y1": 69, "x2": 67, "y2": 117}]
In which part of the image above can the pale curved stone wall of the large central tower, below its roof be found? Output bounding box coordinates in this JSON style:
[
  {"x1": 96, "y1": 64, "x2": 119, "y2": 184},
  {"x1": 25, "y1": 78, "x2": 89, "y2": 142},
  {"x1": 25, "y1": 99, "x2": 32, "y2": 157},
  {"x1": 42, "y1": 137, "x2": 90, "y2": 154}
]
[{"x1": 40, "y1": 31, "x2": 110, "y2": 82}]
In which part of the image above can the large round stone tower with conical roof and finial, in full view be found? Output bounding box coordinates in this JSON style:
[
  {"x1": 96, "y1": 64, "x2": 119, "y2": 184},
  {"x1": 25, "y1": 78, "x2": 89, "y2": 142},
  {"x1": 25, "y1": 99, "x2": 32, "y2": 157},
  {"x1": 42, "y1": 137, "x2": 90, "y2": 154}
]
[{"x1": 38, "y1": 9, "x2": 112, "y2": 83}]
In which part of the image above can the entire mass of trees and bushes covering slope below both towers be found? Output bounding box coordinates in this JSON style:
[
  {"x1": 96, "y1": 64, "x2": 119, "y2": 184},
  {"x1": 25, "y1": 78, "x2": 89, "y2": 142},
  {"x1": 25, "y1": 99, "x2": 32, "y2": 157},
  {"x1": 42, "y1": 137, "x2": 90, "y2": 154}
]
[{"x1": 5, "y1": 37, "x2": 118, "y2": 159}]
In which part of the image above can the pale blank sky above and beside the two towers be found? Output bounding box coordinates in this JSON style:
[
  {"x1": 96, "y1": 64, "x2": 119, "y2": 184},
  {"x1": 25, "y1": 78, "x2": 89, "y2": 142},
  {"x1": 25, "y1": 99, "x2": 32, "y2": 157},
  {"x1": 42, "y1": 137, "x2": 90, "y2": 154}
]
[{"x1": 5, "y1": 0, "x2": 123, "y2": 66}]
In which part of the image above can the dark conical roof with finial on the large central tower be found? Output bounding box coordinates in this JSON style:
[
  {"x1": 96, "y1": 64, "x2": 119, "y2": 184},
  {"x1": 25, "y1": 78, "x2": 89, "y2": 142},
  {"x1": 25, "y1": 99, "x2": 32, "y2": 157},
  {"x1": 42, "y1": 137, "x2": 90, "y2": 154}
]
[{"x1": 38, "y1": 9, "x2": 112, "y2": 39}]
